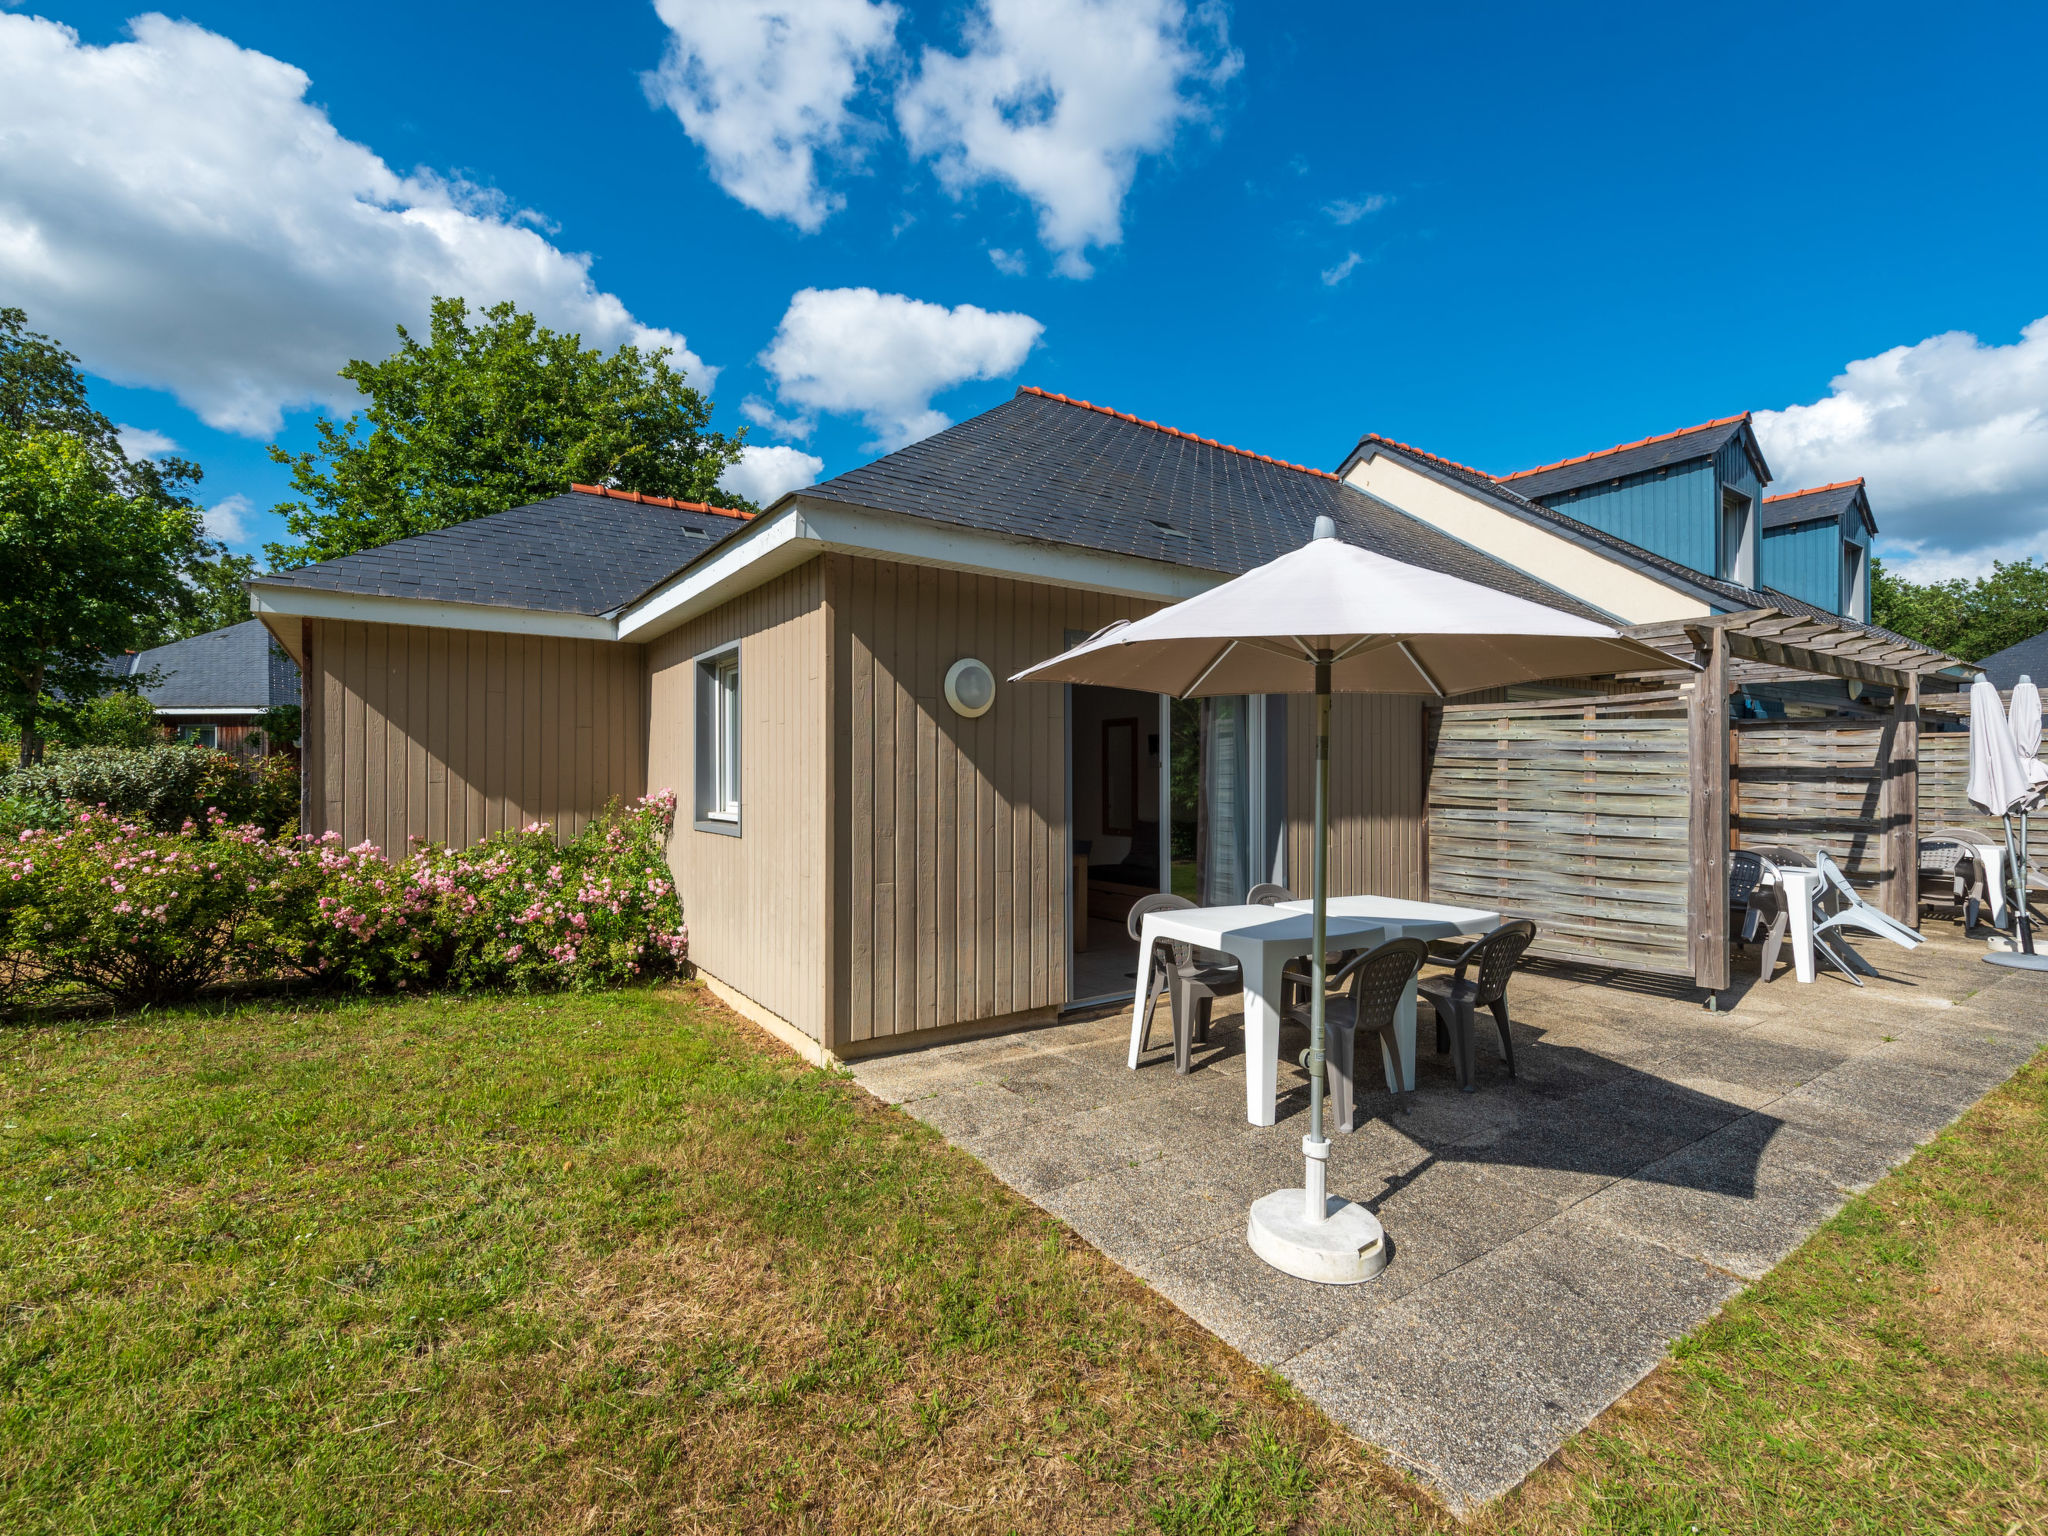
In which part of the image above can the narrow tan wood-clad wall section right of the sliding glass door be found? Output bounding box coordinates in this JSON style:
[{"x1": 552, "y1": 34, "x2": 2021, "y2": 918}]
[{"x1": 1262, "y1": 694, "x2": 1427, "y2": 899}]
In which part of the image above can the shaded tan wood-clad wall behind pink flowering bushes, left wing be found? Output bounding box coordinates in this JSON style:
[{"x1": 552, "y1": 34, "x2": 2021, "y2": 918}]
[{"x1": 301, "y1": 618, "x2": 647, "y2": 856}]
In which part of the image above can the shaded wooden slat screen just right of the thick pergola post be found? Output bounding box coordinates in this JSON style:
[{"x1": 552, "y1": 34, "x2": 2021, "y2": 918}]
[{"x1": 1731, "y1": 721, "x2": 1892, "y2": 891}]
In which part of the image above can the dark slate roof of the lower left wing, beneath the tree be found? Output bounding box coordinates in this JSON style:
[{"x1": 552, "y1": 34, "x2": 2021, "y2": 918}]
[{"x1": 256, "y1": 485, "x2": 748, "y2": 614}]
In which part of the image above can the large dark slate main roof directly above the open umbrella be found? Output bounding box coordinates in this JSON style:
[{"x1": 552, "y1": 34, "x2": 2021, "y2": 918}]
[{"x1": 797, "y1": 387, "x2": 1606, "y2": 621}]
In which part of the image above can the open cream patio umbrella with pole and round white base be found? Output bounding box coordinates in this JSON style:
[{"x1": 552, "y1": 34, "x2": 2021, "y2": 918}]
[{"x1": 1016, "y1": 516, "x2": 1671, "y2": 1284}]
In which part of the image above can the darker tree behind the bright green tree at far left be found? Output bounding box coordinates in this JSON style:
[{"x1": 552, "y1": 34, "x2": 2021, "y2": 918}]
[{"x1": 0, "y1": 307, "x2": 234, "y2": 647}]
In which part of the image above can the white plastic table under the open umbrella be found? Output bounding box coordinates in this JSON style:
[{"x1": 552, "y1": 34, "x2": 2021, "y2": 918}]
[{"x1": 1130, "y1": 897, "x2": 1501, "y2": 1124}]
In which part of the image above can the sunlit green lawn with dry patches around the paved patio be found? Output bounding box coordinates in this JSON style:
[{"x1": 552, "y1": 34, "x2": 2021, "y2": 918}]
[{"x1": 0, "y1": 989, "x2": 2048, "y2": 1536}]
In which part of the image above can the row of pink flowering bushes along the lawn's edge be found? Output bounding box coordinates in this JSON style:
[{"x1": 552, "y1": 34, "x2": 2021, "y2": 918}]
[{"x1": 0, "y1": 791, "x2": 688, "y2": 1006}]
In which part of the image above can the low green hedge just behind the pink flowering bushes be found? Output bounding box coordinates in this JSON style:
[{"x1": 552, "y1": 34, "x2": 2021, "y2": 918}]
[{"x1": 0, "y1": 743, "x2": 299, "y2": 836}]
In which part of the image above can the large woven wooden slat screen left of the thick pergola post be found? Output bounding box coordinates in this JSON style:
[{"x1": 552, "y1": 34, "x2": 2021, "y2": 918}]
[{"x1": 1430, "y1": 696, "x2": 1692, "y2": 977}]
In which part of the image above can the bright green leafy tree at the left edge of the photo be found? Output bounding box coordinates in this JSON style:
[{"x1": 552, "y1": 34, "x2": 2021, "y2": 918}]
[{"x1": 0, "y1": 428, "x2": 201, "y2": 764}]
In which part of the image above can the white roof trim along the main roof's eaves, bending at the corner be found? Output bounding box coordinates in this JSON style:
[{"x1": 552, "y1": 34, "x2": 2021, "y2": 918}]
[{"x1": 618, "y1": 505, "x2": 1225, "y2": 641}]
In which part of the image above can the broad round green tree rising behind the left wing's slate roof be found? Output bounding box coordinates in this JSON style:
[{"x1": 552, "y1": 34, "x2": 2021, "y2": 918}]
[{"x1": 266, "y1": 299, "x2": 752, "y2": 569}]
